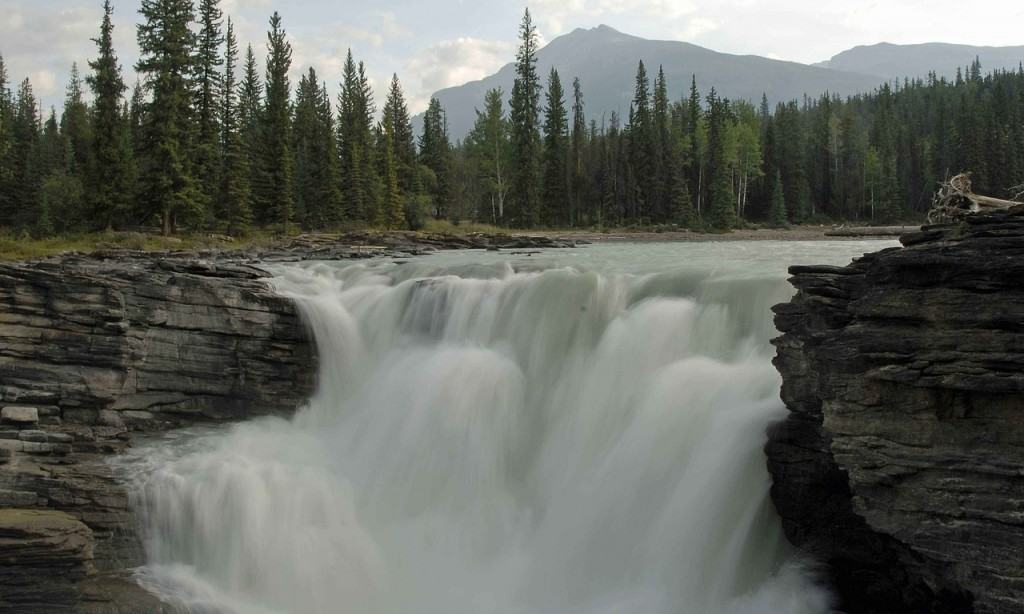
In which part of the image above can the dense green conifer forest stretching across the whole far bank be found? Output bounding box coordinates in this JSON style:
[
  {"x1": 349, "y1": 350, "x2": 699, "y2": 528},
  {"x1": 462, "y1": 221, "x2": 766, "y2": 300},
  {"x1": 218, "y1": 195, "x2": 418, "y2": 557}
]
[{"x1": 0, "y1": 0, "x2": 1024, "y2": 236}]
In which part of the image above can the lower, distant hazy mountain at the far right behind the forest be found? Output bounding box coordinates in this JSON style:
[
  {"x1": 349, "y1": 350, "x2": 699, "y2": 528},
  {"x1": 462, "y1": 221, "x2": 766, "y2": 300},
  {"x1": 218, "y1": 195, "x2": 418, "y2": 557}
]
[{"x1": 814, "y1": 43, "x2": 1024, "y2": 80}]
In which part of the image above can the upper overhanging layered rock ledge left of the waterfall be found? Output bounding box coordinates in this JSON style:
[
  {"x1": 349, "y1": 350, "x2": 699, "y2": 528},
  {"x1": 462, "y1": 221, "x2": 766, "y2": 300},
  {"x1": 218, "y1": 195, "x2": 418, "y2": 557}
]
[{"x1": 0, "y1": 253, "x2": 315, "y2": 427}]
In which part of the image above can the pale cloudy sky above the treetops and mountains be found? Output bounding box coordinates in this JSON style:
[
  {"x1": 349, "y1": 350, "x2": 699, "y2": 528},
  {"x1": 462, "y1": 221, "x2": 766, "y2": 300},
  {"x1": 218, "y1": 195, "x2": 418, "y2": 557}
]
[{"x1": 0, "y1": 0, "x2": 1024, "y2": 112}]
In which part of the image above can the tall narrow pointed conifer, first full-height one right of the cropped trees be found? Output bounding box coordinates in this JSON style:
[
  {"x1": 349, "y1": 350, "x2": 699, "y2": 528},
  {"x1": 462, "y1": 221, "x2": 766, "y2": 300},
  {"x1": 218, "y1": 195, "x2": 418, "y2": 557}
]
[{"x1": 253, "y1": 11, "x2": 295, "y2": 234}]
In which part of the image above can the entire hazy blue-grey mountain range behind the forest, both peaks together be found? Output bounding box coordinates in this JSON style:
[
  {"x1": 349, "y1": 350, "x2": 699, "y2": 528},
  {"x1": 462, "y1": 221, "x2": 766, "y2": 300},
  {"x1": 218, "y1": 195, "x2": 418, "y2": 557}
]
[{"x1": 414, "y1": 25, "x2": 1024, "y2": 140}]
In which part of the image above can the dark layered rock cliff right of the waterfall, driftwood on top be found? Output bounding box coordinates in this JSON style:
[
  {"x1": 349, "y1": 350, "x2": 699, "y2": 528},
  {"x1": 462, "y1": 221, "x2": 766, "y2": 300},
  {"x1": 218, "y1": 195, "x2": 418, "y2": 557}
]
[{"x1": 766, "y1": 208, "x2": 1024, "y2": 614}]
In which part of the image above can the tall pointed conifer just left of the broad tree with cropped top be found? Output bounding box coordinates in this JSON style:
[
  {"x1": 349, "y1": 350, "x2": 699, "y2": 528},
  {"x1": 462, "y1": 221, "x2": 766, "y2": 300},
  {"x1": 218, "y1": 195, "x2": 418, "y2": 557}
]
[{"x1": 88, "y1": 0, "x2": 130, "y2": 228}]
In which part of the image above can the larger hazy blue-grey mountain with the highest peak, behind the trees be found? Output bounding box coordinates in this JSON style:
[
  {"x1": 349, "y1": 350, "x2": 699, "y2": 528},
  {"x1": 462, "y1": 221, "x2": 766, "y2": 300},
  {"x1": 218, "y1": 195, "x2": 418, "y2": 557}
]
[{"x1": 419, "y1": 26, "x2": 884, "y2": 140}]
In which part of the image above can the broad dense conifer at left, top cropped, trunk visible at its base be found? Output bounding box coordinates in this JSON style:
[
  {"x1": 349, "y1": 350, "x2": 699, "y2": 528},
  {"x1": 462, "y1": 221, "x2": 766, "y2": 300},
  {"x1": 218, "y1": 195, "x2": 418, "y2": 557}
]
[{"x1": 135, "y1": 0, "x2": 203, "y2": 234}]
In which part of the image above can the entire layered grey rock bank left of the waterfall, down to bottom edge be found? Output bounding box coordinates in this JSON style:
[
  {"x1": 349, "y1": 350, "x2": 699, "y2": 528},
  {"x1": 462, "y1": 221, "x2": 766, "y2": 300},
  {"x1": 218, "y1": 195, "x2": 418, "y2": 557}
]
[{"x1": 0, "y1": 252, "x2": 316, "y2": 613}]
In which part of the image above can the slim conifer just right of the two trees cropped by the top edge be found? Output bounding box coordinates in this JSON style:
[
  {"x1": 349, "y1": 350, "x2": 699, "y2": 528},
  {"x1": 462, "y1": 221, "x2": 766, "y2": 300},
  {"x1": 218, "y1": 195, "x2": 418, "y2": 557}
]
[{"x1": 217, "y1": 19, "x2": 250, "y2": 235}]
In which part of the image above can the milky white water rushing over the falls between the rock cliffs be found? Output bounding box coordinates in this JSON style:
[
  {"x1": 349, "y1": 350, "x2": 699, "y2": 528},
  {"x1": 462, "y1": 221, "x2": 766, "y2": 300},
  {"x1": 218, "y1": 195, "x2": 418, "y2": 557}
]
[{"x1": 117, "y1": 243, "x2": 879, "y2": 614}]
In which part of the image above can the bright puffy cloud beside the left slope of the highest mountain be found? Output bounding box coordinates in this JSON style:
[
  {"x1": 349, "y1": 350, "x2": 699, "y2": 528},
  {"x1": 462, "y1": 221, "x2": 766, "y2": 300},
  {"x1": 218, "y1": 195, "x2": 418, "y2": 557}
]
[{"x1": 403, "y1": 38, "x2": 515, "y2": 113}]
